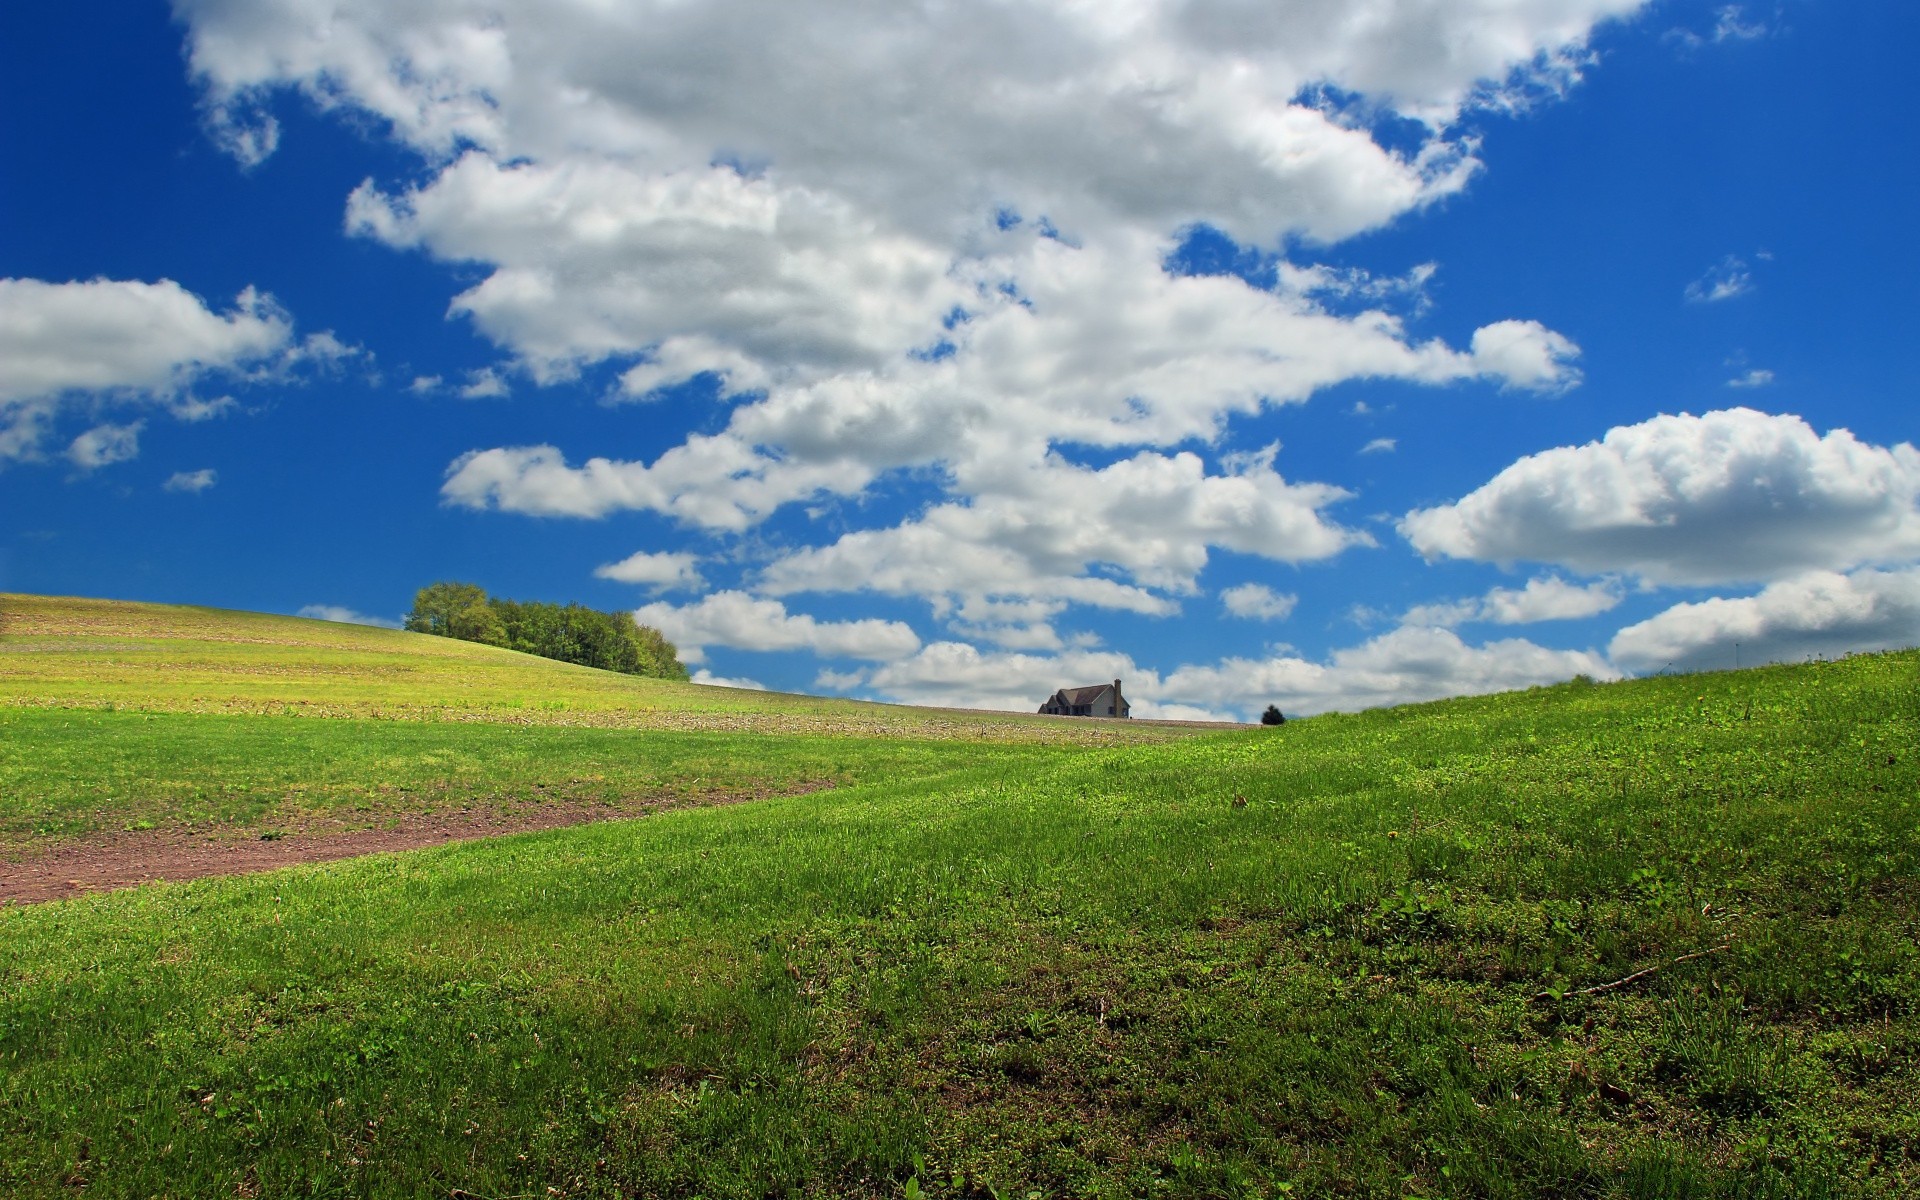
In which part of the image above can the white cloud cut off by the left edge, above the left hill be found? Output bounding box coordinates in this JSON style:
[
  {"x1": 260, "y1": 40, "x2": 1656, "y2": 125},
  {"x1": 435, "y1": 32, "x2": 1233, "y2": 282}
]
[{"x1": 0, "y1": 278, "x2": 341, "y2": 468}]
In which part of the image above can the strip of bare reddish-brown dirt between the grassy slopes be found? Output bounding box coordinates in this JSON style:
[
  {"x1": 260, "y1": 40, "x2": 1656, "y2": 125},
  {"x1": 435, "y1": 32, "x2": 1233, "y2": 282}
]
[{"x1": 0, "y1": 783, "x2": 829, "y2": 904}]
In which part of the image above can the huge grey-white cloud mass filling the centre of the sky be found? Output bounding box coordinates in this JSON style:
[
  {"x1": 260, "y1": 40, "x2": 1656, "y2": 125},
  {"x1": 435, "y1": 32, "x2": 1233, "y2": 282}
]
[{"x1": 177, "y1": 0, "x2": 1620, "y2": 625}]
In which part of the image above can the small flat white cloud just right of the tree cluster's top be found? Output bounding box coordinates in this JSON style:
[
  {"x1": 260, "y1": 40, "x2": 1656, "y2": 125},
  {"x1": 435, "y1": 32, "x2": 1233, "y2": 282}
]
[{"x1": 634, "y1": 591, "x2": 920, "y2": 662}]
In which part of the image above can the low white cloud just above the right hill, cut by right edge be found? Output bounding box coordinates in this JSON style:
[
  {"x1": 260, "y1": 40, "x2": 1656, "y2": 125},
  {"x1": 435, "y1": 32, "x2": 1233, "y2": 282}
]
[{"x1": 1607, "y1": 566, "x2": 1920, "y2": 672}]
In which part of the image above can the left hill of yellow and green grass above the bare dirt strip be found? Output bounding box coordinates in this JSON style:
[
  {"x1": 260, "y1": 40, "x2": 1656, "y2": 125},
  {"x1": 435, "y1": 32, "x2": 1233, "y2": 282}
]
[{"x1": 0, "y1": 595, "x2": 1198, "y2": 840}]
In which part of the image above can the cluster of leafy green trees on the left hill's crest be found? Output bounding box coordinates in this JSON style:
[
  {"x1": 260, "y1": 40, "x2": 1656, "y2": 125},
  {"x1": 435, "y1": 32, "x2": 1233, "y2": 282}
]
[{"x1": 407, "y1": 584, "x2": 687, "y2": 680}]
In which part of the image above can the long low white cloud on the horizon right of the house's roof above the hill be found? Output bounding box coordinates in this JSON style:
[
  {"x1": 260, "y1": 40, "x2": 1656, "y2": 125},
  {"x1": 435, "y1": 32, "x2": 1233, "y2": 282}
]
[{"x1": 1152, "y1": 626, "x2": 1619, "y2": 718}]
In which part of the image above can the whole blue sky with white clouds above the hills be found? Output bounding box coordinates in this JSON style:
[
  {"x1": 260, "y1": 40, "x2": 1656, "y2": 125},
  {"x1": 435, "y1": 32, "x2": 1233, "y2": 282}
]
[{"x1": 0, "y1": 0, "x2": 1920, "y2": 718}]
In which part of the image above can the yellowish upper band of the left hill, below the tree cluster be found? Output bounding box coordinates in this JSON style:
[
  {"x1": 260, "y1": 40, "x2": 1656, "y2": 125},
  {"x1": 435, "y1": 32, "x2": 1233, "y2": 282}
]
[{"x1": 0, "y1": 595, "x2": 1217, "y2": 745}]
